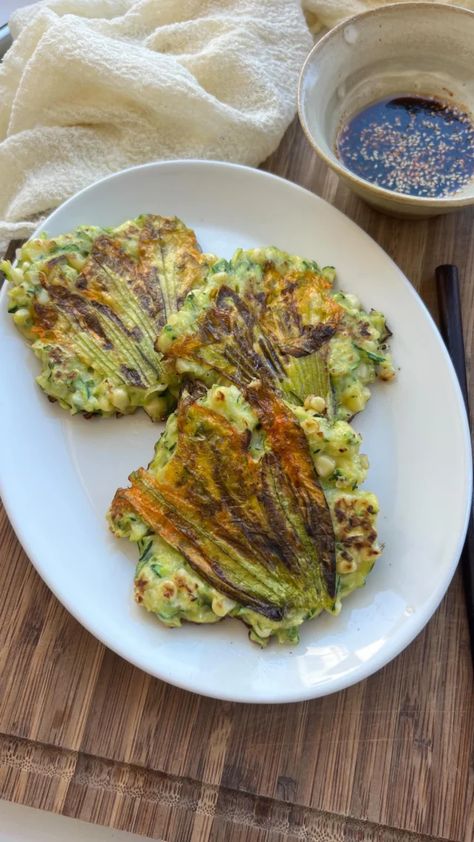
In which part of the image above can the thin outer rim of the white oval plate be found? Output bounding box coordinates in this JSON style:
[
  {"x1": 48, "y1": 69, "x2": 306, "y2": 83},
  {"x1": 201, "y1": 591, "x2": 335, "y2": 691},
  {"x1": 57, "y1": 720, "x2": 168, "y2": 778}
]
[{"x1": 0, "y1": 158, "x2": 473, "y2": 704}]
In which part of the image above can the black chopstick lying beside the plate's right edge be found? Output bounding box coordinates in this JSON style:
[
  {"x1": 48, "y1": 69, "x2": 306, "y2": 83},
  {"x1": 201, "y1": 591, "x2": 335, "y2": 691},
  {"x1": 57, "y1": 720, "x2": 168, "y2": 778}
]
[{"x1": 436, "y1": 264, "x2": 474, "y2": 668}]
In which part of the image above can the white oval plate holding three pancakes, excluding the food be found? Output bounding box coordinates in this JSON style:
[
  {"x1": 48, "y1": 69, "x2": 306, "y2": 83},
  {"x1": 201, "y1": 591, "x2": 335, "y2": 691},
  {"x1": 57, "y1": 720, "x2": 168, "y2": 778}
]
[{"x1": 0, "y1": 161, "x2": 471, "y2": 702}]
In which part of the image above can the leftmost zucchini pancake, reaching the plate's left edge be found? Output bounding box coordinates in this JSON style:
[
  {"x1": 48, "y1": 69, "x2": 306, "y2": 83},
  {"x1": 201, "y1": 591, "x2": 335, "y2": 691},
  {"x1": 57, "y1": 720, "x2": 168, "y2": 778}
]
[{"x1": 1, "y1": 215, "x2": 213, "y2": 419}]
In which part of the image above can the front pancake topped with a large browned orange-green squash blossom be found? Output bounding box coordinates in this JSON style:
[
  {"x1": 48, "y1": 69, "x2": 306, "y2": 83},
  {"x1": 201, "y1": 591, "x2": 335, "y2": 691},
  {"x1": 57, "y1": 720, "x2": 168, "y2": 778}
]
[{"x1": 109, "y1": 381, "x2": 379, "y2": 645}]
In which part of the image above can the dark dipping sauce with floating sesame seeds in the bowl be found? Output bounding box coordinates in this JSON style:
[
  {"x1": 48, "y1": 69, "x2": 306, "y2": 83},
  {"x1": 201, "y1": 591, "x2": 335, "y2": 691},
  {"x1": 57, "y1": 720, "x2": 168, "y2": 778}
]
[{"x1": 336, "y1": 96, "x2": 474, "y2": 197}]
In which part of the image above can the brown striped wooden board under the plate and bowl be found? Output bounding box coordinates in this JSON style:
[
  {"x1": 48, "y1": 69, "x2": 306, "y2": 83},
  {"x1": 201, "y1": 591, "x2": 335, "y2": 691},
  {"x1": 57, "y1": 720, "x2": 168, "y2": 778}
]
[{"x1": 0, "y1": 122, "x2": 474, "y2": 842}]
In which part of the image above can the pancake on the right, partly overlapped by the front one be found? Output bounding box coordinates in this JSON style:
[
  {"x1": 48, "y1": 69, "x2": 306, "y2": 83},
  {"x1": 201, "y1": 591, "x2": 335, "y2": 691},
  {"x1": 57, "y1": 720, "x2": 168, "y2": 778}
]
[{"x1": 156, "y1": 247, "x2": 394, "y2": 419}]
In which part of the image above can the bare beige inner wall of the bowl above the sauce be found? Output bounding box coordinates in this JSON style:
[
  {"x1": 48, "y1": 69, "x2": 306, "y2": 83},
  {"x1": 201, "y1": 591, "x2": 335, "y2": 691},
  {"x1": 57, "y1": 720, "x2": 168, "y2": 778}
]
[{"x1": 300, "y1": 3, "x2": 474, "y2": 201}]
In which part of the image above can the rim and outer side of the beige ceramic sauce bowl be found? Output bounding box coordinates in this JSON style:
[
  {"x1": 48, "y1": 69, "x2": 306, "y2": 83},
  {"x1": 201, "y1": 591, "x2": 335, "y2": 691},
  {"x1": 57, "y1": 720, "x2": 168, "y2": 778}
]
[{"x1": 298, "y1": 0, "x2": 474, "y2": 209}]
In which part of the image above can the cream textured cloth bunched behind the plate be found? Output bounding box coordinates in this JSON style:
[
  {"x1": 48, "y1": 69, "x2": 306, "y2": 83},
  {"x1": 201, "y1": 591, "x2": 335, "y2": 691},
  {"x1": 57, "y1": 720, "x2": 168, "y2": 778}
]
[{"x1": 0, "y1": 0, "x2": 312, "y2": 247}]
